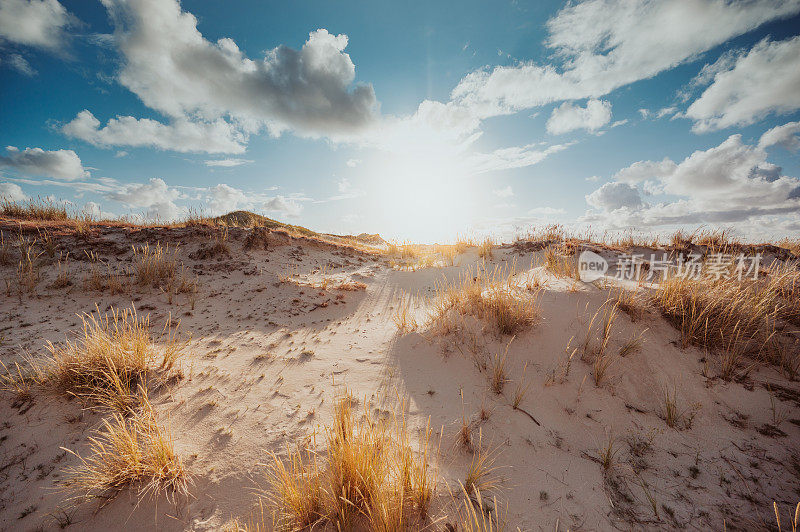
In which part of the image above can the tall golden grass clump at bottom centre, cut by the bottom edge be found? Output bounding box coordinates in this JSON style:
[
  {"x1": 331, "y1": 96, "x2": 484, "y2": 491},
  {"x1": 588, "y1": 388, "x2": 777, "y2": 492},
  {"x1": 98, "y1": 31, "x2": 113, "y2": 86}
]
[{"x1": 265, "y1": 396, "x2": 436, "y2": 531}]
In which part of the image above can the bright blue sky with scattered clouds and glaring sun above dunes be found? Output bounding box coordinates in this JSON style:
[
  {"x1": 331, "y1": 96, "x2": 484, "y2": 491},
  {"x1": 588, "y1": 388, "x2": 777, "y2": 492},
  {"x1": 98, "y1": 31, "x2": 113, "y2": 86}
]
[{"x1": 0, "y1": 0, "x2": 800, "y2": 242}]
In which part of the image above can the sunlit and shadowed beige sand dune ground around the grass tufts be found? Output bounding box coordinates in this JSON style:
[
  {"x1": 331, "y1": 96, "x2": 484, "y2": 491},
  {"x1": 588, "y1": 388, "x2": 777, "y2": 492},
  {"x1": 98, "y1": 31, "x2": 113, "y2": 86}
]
[{"x1": 0, "y1": 215, "x2": 800, "y2": 530}]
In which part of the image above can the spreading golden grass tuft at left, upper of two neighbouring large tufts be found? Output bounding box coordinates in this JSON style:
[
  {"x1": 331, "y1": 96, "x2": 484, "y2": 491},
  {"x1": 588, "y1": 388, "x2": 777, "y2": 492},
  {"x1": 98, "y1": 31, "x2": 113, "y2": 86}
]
[{"x1": 2, "y1": 309, "x2": 186, "y2": 412}]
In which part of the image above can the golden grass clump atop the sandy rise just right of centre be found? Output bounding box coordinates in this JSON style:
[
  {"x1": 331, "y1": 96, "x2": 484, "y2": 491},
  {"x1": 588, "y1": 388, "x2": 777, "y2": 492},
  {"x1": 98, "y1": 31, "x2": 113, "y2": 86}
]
[{"x1": 427, "y1": 267, "x2": 539, "y2": 335}]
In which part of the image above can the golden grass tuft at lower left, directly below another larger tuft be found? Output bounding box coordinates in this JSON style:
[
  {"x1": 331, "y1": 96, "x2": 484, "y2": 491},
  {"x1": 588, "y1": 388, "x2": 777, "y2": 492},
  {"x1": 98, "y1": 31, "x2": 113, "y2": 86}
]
[{"x1": 62, "y1": 393, "x2": 189, "y2": 502}]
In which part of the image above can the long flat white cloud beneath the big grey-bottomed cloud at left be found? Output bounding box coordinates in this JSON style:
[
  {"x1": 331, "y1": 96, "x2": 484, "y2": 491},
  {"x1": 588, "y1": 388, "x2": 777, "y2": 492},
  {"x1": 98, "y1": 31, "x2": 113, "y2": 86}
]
[{"x1": 61, "y1": 109, "x2": 246, "y2": 153}]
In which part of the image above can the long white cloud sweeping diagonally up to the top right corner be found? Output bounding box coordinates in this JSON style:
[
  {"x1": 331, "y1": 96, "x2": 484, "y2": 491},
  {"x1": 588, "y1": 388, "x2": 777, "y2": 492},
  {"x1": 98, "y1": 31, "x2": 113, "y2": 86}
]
[{"x1": 451, "y1": 0, "x2": 800, "y2": 117}]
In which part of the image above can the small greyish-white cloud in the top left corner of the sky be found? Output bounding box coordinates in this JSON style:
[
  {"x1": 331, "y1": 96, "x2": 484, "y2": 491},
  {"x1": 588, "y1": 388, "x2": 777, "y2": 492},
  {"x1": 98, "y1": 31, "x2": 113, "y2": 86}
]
[{"x1": 0, "y1": 0, "x2": 72, "y2": 49}]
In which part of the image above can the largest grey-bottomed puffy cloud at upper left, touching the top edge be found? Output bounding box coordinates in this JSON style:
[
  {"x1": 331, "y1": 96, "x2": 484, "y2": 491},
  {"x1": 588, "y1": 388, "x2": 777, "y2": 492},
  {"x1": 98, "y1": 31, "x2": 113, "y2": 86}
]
[{"x1": 103, "y1": 0, "x2": 376, "y2": 136}]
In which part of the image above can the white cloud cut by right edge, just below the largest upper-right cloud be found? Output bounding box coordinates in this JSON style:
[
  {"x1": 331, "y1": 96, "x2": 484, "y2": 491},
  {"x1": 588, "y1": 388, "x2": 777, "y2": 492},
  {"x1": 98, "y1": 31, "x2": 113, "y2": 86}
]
[{"x1": 686, "y1": 36, "x2": 800, "y2": 132}]
